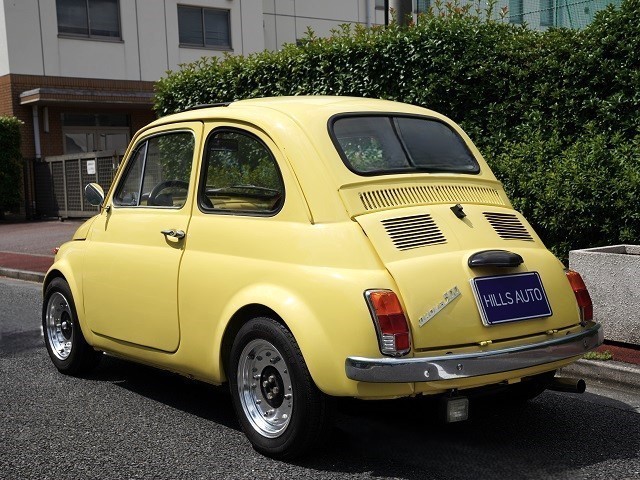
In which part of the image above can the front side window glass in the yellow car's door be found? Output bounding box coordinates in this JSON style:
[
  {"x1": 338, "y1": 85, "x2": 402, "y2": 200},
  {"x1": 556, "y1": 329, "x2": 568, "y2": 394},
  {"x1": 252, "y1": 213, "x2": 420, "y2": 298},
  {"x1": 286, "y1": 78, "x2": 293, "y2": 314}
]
[{"x1": 113, "y1": 132, "x2": 195, "y2": 208}]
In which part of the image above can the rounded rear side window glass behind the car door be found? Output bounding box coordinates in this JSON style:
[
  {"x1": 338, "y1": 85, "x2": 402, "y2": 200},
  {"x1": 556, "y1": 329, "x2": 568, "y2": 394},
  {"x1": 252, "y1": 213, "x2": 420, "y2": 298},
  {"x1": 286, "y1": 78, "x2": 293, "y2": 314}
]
[{"x1": 199, "y1": 130, "x2": 284, "y2": 214}]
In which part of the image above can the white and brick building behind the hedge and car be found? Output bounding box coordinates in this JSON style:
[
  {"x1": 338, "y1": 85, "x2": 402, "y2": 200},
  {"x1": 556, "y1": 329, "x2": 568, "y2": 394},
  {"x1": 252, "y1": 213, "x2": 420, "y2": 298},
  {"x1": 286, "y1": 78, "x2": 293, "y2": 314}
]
[{"x1": 0, "y1": 0, "x2": 619, "y2": 218}]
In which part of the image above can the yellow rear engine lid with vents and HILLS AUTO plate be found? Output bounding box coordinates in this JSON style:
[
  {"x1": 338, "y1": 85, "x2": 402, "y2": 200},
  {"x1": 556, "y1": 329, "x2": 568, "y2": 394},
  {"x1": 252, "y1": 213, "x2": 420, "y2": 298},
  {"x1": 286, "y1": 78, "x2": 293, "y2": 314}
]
[{"x1": 355, "y1": 204, "x2": 579, "y2": 351}]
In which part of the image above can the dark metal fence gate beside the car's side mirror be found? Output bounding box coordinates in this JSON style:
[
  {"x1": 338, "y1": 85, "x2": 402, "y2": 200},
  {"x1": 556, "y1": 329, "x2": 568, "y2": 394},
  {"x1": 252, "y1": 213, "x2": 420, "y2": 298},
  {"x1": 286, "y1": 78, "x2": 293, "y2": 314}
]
[{"x1": 34, "y1": 150, "x2": 124, "y2": 218}]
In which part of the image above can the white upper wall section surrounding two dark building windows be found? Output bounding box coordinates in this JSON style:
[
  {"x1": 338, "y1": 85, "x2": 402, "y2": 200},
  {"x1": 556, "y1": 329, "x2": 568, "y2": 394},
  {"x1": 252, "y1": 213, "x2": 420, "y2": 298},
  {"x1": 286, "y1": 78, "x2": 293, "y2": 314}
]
[{"x1": 0, "y1": 0, "x2": 265, "y2": 81}]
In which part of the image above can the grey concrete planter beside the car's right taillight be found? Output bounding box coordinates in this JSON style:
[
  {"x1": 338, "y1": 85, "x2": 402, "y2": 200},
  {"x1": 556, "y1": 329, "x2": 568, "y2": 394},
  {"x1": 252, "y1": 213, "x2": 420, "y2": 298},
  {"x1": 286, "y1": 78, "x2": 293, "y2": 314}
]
[{"x1": 569, "y1": 245, "x2": 640, "y2": 345}]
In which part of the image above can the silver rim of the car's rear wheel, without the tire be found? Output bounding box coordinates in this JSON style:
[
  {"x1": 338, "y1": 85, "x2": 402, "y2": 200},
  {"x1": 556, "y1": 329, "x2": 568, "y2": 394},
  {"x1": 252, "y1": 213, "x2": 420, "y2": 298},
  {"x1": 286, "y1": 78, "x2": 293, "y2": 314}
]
[{"x1": 237, "y1": 339, "x2": 293, "y2": 438}]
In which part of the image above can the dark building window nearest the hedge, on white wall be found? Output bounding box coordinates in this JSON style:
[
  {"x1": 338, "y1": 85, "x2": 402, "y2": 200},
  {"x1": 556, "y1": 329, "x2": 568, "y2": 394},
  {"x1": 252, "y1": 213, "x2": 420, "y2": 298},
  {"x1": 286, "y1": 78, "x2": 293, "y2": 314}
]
[{"x1": 178, "y1": 5, "x2": 231, "y2": 49}]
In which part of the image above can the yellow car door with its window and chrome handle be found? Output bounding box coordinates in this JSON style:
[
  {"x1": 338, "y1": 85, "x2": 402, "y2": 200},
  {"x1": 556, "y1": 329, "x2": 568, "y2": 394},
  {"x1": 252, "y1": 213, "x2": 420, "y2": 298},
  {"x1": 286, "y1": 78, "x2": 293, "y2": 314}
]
[{"x1": 83, "y1": 122, "x2": 202, "y2": 352}]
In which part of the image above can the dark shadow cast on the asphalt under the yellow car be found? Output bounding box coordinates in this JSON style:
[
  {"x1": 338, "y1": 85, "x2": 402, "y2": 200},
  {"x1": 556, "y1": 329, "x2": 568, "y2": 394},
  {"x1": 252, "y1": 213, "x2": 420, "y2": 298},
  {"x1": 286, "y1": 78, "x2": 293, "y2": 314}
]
[{"x1": 80, "y1": 356, "x2": 640, "y2": 480}]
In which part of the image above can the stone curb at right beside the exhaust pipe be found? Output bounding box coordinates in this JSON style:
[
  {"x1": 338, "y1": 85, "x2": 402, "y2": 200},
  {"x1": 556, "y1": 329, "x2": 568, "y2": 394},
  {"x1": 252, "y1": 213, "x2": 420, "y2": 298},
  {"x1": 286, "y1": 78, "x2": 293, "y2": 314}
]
[{"x1": 558, "y1": 360, "x2": 640, "y2": 390}]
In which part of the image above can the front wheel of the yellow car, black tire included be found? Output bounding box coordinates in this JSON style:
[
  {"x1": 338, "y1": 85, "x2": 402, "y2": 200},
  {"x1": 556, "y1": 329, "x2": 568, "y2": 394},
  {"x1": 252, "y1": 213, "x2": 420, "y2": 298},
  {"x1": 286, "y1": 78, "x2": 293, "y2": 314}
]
[{"x1": 42, "y1": 278, "x2": 100, "y2": 375}]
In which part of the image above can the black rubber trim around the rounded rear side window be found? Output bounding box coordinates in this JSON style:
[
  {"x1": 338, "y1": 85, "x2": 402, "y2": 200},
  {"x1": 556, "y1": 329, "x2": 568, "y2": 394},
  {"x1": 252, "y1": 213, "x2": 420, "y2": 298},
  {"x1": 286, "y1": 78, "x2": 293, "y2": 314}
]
[{"x1": 195, "y1": 125, "x2": 287, "y2": 218}]
